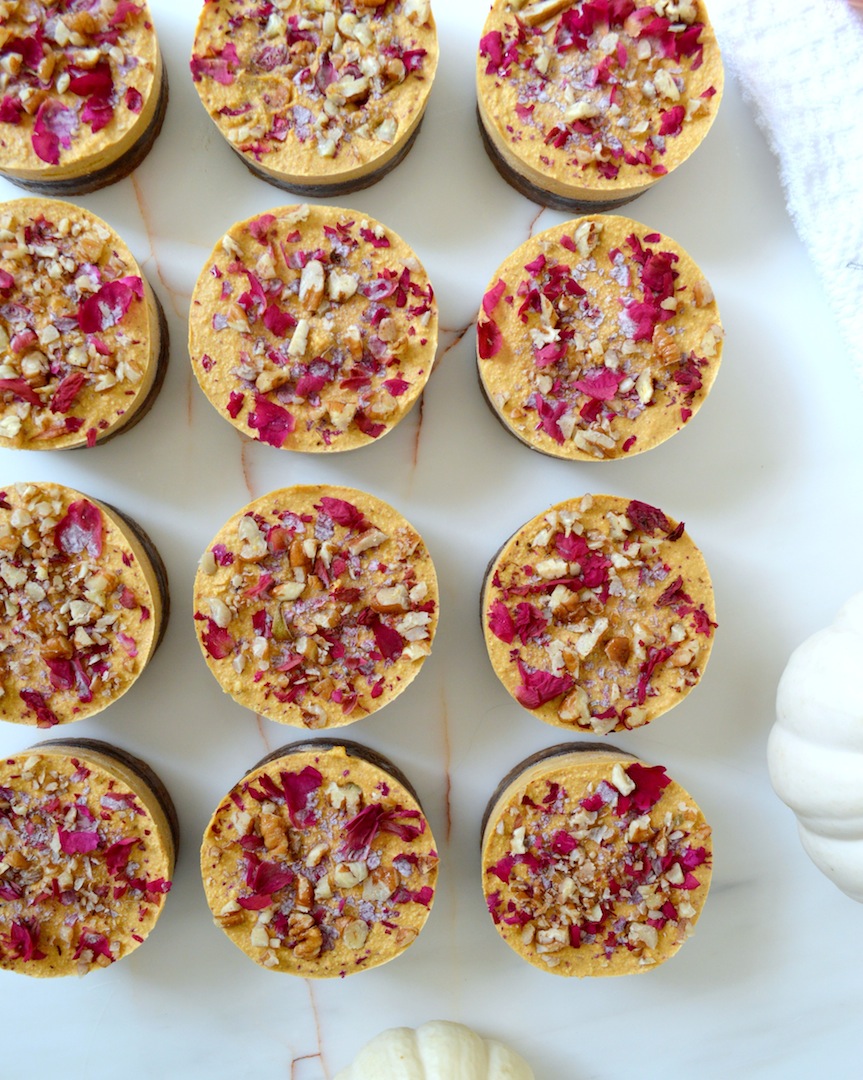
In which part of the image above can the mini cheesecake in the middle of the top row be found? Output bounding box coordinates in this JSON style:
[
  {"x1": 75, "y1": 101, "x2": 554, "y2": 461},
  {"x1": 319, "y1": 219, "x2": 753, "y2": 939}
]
[{"x1": 191, "y1": 0, "x2": 439, "y2": 198}]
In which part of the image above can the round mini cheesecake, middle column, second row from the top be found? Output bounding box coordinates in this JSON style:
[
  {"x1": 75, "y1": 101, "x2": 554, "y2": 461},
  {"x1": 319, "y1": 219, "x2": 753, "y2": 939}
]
[{"x1": 189, "y1": 204, "x2": 437, "y2": 453}]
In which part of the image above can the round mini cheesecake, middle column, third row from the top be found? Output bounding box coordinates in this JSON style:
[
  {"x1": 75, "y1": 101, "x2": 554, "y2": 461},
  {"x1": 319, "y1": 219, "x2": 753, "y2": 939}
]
[{"x1": 194, "y1": 485, "x2": 440, "y2": 729}]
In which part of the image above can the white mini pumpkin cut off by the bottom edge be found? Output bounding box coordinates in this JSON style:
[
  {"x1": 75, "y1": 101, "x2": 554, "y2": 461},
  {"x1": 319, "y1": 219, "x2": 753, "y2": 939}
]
[{"x1": 336, "y1": 1020, "x2": 535, "y2": 1080}]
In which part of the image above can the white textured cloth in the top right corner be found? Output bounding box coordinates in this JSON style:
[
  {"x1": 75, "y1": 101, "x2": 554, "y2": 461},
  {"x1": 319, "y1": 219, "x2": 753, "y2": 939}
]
[{"x1": 707, "y1": 0, "x2": 863, "y2": 380}]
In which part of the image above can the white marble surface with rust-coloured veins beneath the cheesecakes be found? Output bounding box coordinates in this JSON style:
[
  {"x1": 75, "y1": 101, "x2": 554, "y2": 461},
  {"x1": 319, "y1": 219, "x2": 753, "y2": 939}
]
[{"x1": 0, "y1": 0, "x2": 863, "y2": 1080}]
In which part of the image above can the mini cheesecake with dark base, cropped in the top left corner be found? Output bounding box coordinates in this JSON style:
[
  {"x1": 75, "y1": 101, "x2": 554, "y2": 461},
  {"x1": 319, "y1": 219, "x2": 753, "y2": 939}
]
[{"x1": 0, "y1": 0, "x2": 167, "y2": 197}]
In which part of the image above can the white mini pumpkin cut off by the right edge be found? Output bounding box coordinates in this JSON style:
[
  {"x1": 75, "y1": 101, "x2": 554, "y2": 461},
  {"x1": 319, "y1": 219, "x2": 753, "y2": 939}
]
[{"x1": 767, "y1": 593, "x2": 863, "y2": 903}]
